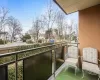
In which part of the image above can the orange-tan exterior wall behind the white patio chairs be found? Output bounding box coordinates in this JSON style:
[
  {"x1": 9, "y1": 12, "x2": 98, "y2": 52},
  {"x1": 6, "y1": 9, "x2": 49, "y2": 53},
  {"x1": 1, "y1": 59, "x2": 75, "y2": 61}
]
[{"x1": 79, "y1": 5, "x2": 100, "y2": 57}]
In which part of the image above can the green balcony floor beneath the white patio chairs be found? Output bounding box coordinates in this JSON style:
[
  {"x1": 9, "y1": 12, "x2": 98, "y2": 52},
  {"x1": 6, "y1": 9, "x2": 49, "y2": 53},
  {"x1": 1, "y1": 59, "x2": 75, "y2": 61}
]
[{"x1": 56, "y1": 68, "x2": 98, "y2": 80}]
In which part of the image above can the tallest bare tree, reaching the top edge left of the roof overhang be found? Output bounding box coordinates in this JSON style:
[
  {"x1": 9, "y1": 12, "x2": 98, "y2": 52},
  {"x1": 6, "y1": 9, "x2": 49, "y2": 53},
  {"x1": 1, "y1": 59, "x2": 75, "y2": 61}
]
[{"x1": 42, "y1": 1, "x2": 56, "y2": 38}]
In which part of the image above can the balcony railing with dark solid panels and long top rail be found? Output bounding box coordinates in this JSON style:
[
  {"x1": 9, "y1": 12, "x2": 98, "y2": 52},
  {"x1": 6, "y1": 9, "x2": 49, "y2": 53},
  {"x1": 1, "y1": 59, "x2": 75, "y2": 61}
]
[{"x1": 0, "y1": 43, "x2": 67, "y2": 80}]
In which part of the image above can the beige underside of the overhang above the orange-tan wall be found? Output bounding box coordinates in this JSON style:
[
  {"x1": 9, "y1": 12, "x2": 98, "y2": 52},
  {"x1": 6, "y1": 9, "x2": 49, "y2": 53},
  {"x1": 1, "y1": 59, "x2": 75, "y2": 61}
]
[{"x1": 54, "y1": 0, "x2": 100, "y2": 14}]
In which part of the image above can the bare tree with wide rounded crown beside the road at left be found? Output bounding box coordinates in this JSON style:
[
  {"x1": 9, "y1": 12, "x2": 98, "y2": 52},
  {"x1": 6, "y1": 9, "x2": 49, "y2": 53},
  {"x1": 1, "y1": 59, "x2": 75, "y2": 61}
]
[{"x1": 7, "y1": 16, "x2": 22, "y2": 42}]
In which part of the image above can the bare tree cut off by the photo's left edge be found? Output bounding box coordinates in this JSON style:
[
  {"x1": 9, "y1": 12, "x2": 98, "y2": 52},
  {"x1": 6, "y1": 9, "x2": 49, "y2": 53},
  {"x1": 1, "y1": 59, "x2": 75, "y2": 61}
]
[{"x1": 0, "y1": 7, "x2": 8, "y2": 32}]
